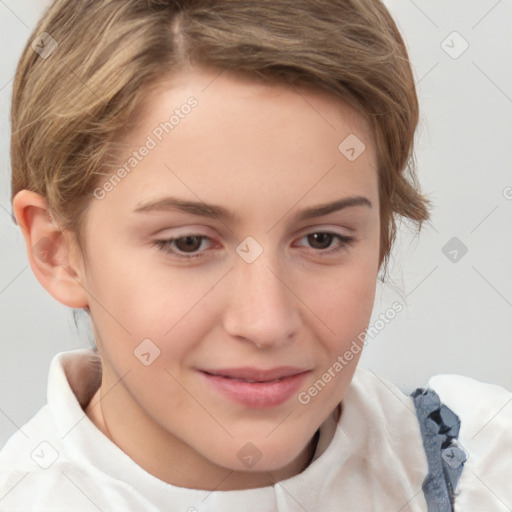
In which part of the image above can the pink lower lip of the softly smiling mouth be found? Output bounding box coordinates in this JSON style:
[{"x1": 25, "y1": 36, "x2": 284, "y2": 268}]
[{"x1": 200, "y1": 372, "x2": 310, "y2": 409}]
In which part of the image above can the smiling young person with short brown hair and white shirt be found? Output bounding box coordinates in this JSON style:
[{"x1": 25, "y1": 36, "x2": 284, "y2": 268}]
[{"x1": 0, "y1": 0, "x2": 512, "y2": 512}]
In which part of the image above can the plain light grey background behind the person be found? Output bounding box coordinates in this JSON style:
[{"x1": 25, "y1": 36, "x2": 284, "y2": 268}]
[{"x1": 0, "y1": 0, "x2": 512, "y2": 445}]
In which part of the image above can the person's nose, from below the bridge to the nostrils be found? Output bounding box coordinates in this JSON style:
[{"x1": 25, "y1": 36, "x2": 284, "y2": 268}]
[{"x1": 224, "y1": 251, "x2": 301, "y2": 348}]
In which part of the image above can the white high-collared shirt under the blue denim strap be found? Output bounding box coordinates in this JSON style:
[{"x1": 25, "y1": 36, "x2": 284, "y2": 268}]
[{"x1": 0, "y1": 349, "x2": 512, "y2": 512}]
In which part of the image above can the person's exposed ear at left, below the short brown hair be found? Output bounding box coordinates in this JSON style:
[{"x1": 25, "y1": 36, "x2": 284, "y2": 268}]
[{"x1": 12, "y1": 190, "x2": 88, "y2": 308}]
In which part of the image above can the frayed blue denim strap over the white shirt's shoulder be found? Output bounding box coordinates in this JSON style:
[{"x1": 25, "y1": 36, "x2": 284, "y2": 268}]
[{"x1": 411, "y1": 388, "x2": 467, "y2": 512}]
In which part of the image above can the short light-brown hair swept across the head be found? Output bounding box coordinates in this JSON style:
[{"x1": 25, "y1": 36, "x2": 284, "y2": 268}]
[{"x1": 11, "y1": 0, "x2": 429, "y2": 272}]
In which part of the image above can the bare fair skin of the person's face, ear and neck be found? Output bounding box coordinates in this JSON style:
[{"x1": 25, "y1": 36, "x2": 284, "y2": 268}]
[{"x1": 13, "y1": 68, "x2": 381, "y2": 490}]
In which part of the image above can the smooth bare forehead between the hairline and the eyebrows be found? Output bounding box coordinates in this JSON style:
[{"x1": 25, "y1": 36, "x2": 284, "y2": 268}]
[{"x1": 96, "y1": 68, "x2": 376, "y2": 220}]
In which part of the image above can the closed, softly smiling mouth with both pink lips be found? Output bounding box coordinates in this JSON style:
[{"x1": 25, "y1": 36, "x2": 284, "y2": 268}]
[{"x1": 199, "y1": 366, "x2": 311, "y2": 409}]
